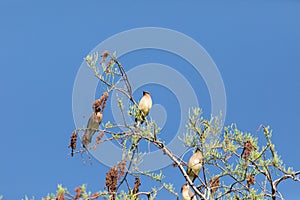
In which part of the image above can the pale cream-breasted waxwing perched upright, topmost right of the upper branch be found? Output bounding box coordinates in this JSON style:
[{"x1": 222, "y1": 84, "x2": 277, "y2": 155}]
[{"x1": 134, "y1": 91, "x2": 152, "y2": 127}]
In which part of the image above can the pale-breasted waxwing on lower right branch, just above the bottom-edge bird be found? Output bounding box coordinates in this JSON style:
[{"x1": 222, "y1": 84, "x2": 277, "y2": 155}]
[{"x1": 187, "y1": 148, "x2": 204, "y2": 182}]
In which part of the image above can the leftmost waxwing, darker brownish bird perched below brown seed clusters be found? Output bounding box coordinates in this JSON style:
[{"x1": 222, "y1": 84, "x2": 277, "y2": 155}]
[{"x1": 82, "y1": 107, "x2": 102, "y2": 148}]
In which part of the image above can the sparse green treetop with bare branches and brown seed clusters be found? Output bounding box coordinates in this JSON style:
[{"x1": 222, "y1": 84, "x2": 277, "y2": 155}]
[{"x1": 44, "y1": 51, "x2": 300, "y2": 200}]
